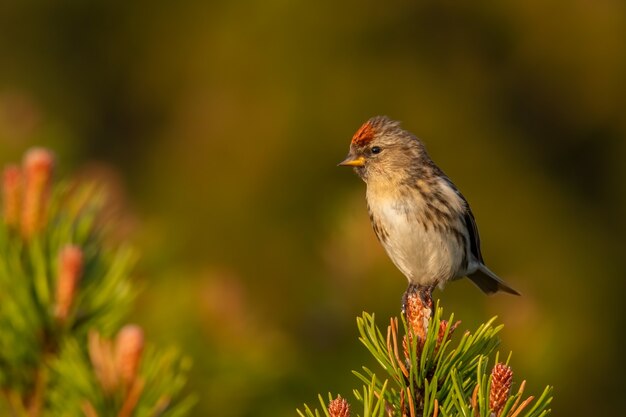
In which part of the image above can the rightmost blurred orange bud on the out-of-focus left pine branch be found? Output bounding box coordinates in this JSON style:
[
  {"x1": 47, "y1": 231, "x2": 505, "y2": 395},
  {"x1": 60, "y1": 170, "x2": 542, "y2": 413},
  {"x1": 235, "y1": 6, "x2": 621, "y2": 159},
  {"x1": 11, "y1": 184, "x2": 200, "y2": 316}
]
[{"x1": 115, "y1": 324, "x2": 144, "y2": 386}]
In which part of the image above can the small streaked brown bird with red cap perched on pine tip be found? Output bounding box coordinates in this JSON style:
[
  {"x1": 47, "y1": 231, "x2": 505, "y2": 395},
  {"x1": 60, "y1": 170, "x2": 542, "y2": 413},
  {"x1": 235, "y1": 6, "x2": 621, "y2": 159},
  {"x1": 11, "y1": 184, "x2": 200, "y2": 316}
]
[{"x1": 339, "y1": 116, "x2": 519, "y2": 295}]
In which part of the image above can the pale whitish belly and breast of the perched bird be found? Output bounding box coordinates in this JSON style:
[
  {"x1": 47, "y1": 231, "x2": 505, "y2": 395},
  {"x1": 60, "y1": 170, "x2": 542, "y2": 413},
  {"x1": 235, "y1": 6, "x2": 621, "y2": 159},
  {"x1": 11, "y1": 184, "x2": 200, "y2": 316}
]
[{"x1": 370, "y1": 195, "x2": 464, "y2": 285}]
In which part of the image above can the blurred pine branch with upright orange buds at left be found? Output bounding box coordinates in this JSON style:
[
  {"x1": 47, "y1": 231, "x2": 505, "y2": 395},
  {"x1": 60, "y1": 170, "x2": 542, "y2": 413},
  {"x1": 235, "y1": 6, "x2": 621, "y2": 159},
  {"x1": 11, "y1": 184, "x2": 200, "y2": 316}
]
[{"x1": 0, "y1": 149, "x2": 194, "y2": 417}]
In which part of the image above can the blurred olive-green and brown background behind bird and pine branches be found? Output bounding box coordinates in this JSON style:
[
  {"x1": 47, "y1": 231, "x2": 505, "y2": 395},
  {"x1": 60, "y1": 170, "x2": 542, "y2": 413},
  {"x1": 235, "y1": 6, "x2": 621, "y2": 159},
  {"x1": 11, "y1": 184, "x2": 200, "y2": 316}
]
[{"x1": 0, "y1": 0, "x2": 626, "y2": 417}]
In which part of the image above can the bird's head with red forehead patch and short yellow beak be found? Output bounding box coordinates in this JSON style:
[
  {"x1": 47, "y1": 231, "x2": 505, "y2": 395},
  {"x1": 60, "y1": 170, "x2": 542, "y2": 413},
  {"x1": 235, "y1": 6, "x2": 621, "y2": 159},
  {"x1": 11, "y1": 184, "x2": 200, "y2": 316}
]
[{"x1": 339, "y1": 116, "x2": 428, "y2": 182}]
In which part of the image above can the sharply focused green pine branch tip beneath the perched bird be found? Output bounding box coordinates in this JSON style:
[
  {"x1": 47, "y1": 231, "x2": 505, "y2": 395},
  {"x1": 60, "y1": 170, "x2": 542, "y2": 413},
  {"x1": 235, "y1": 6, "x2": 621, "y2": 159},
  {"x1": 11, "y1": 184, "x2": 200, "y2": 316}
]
[{"x1": 298, "y1": 303, "x2": 552, "y2": 417}]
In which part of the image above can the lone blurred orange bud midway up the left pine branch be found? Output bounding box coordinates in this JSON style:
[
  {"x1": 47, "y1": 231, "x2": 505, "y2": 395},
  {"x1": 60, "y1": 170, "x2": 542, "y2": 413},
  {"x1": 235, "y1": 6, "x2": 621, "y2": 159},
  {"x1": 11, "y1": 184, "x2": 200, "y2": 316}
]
[{"x1": 55, "y1": 245, "x2": 83, "y2": 321}]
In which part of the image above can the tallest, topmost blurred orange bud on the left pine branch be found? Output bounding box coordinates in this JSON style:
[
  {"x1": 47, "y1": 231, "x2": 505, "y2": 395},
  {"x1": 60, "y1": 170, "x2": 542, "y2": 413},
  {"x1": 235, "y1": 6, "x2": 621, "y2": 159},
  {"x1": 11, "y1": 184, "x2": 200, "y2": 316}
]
[{"x1": 22, "y1": 148, "x2": 54, "y2": 238}]
